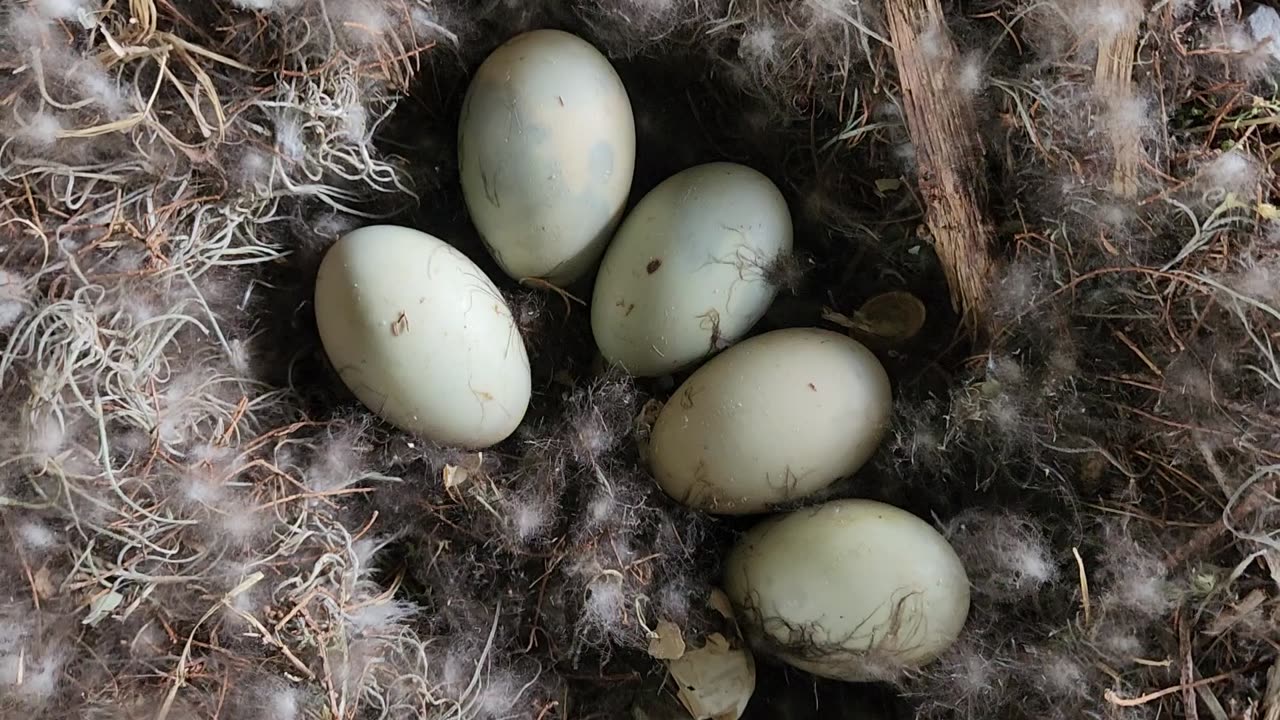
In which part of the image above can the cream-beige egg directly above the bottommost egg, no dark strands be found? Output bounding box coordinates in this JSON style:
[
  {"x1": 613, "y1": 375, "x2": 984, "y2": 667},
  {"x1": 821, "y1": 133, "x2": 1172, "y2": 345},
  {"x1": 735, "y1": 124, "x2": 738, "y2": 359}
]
[{"x1": 649, "y1": 328, "x2": 892, "y2": 514}]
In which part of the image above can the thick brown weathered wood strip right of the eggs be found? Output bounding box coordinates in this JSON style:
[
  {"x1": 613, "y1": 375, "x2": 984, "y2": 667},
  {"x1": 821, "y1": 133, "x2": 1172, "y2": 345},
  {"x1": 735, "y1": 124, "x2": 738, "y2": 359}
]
[{"x1": 884, "y1": 0, "x2": 996, "y2": 336}]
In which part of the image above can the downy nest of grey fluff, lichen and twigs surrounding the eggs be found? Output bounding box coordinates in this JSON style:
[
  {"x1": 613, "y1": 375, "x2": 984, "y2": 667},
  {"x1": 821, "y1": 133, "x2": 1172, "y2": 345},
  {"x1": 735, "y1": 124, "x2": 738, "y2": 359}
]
[{"x1": 0, "y1": 0, "x2": 1280, "y2": 720}]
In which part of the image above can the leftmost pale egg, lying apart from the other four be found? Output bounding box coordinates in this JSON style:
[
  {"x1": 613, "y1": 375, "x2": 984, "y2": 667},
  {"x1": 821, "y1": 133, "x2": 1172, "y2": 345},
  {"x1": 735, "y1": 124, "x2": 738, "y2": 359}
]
[{"x1": 315, "y1": 225, "x2": 531, "y2": 448}]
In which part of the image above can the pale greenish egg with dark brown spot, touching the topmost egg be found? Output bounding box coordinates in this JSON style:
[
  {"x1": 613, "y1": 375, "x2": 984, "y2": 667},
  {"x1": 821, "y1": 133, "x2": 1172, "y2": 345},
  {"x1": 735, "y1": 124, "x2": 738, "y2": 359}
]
[{"x1": 591, "y1": 163, "x2": 792, "y2": 377}]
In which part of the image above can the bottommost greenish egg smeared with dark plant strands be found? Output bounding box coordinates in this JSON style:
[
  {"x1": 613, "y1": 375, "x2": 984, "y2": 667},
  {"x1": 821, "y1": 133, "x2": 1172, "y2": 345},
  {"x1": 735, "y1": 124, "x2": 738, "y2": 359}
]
[{"x1": 724, "y1": 500, "x2": 969, "y2": 682}]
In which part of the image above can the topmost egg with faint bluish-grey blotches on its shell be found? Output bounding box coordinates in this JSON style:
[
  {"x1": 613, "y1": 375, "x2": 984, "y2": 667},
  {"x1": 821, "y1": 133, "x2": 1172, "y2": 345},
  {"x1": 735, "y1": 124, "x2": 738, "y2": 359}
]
[{"x1": 458, "y1": 29, "x2": 636, "y2": 286}]
